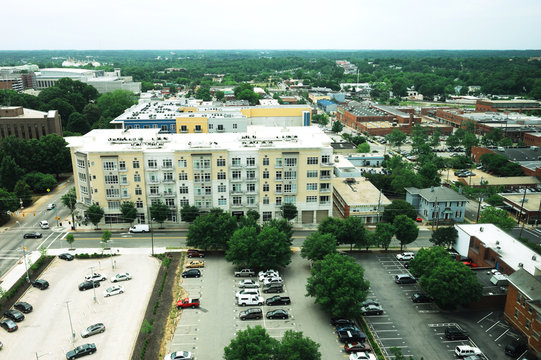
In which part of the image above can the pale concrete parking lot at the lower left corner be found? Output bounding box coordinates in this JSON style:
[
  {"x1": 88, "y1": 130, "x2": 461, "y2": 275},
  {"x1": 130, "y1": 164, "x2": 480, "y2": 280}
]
[{"x1": 0, "y1": 255, "x2": 159, "y2": 360}]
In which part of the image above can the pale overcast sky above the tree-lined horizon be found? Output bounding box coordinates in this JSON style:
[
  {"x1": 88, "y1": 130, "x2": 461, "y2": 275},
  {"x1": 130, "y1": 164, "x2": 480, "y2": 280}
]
[{"x1": 4, "y1": 0, "x2": 541, "y2": 50}]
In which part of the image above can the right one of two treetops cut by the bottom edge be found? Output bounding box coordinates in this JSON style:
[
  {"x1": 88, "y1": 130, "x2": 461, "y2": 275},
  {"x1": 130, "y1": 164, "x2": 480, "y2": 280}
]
[{"x1": 274, "y1": 330, "x2": 321, "y2": 360}]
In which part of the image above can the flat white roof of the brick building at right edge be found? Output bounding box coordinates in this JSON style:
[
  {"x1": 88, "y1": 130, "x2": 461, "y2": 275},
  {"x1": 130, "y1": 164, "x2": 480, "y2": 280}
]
[{"x1": 455, "y1": 224, "x2": 541, "y2": 274}]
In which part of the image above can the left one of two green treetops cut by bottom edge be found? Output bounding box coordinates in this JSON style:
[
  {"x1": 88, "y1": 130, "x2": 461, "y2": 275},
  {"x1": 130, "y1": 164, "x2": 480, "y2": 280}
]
[{"x1": 224, "y1": 325, "x2": 280, "y2": 360}]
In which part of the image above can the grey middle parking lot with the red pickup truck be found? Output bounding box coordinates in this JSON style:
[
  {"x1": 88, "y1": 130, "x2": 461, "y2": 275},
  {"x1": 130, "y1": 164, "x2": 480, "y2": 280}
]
[{"x1": 168, "y1": 253, "x2": 354, "y2": 360}]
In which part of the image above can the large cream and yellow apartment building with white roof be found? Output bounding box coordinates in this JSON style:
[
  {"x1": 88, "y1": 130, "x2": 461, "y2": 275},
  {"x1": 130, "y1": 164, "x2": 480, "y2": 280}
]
[{"x1": 66, "y1": 126, "x2": 333, "y2": 224}]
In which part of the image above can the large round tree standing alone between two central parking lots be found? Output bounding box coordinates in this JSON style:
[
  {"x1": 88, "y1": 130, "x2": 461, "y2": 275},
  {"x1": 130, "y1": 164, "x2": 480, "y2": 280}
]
[{"x1": 306, "y1": 254, "x2": 370, "y2": 318}]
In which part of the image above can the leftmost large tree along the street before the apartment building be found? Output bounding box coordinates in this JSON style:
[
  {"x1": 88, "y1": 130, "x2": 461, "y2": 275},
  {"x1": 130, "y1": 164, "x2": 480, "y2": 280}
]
[{"x1": 186, "y1": 209, "x2": 237, "y2": 250}]
